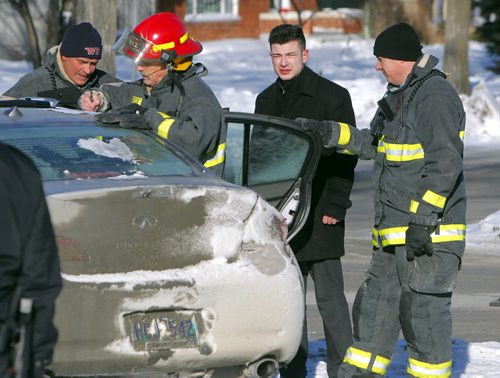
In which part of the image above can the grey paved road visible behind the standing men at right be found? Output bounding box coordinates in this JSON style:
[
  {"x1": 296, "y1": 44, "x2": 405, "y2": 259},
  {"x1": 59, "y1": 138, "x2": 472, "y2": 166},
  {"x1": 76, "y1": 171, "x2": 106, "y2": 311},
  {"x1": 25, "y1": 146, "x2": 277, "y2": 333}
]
[{"x1": 307, "y1": 146, "x2": 500, "y2": 342}]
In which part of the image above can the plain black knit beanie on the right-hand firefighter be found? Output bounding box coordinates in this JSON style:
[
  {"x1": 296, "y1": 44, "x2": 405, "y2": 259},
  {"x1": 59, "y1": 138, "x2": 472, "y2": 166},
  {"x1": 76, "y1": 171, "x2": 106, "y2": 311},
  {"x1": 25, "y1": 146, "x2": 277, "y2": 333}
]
[{"x1": 373, "y1": 22, "x2": 422, "y2": 62}]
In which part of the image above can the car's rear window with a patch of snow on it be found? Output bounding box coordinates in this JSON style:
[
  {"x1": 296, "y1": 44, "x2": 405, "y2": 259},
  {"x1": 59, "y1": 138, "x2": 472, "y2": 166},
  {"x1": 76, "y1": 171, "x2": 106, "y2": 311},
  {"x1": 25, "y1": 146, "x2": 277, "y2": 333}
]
[{"x1": 2, "y1": 125, "x2": 193, "y2": 180}]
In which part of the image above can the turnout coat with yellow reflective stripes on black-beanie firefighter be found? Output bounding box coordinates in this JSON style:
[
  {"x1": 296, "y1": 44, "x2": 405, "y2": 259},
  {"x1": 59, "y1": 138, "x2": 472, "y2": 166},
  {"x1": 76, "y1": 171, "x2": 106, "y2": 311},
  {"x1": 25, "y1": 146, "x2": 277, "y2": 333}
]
[{"x1": 328, "y1": 54, "x2": 466, "y2": 257}]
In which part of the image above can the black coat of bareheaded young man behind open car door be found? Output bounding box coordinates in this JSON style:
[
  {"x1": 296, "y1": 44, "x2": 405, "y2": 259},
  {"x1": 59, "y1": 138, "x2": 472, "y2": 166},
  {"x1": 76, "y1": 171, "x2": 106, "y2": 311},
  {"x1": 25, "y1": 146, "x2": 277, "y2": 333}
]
[{"x1": 255, "y1": 67, "x2": 357, "y2": 261}]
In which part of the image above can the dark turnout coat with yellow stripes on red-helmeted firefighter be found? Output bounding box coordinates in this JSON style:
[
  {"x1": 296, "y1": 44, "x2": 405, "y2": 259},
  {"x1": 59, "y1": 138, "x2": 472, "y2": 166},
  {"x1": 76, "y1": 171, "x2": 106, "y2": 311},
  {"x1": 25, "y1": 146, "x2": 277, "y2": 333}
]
[{"x1": 96, "y1": 63, "x2": 226, "y2": 176}]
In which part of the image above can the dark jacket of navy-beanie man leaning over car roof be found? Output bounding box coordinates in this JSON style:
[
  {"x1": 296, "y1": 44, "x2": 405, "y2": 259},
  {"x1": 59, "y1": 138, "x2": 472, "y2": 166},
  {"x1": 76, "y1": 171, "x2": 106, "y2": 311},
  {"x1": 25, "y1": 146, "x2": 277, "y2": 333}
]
[{"x1": 3, "y1": 46, "x2": 121, "y2": 109}]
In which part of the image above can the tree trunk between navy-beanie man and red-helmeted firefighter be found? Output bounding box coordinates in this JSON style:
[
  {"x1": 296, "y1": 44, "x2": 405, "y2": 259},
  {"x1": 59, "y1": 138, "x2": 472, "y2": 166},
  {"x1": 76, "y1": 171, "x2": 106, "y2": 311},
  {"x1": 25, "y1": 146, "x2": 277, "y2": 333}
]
[{"x1": 76, "y1": 0, "x2": 117, "y2": 75}]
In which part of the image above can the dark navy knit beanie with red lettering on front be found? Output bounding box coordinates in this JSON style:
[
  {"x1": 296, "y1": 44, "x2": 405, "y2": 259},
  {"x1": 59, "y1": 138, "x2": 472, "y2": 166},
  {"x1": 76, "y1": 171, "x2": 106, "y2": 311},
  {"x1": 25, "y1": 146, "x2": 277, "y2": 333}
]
[{"x1": 60, "y1": 22, "x2": 102, "y2": 59}]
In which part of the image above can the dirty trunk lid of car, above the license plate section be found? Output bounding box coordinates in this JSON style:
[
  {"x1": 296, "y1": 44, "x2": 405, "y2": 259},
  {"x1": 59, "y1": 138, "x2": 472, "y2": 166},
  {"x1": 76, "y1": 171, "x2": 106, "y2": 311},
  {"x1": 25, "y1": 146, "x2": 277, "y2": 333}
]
[{"x1": 48, "y1": 185, "x2": 274, "y2": 275}]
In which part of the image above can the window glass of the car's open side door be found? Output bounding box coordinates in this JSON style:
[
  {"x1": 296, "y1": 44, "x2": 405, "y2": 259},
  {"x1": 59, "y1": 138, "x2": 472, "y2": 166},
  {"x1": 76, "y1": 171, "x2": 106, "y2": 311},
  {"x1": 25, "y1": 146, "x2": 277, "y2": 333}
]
[{"x1": 224, "y1": 123, "x2": 309, "y2": 186}]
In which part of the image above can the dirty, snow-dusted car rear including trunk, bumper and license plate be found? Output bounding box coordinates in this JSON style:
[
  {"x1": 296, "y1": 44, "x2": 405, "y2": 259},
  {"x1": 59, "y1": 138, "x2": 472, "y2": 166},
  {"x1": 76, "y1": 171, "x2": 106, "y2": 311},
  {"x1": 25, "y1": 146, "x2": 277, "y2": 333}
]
[{"x1": 48, "y1": 185, "x2": 303, "y2": 375}]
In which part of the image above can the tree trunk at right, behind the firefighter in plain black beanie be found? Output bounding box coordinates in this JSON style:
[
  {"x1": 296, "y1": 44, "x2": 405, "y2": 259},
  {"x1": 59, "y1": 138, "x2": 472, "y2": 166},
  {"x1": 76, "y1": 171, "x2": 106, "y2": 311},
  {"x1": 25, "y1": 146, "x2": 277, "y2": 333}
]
[{"x1": 444, "y1": 0, "x2": 471, "y2": 95}]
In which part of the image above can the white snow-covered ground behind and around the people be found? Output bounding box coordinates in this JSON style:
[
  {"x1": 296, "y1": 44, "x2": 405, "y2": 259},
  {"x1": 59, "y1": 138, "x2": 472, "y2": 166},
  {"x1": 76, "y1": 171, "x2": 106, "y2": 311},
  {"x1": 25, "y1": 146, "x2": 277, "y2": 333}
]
[{"x1": 0, "y1": 36, "x2": 500, "y2": 378}]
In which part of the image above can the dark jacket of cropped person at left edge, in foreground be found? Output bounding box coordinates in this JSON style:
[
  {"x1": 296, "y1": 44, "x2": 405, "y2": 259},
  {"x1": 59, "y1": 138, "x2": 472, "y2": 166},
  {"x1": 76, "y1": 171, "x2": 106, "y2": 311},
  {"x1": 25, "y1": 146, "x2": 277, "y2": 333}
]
[{"x1": 0, "y1": 143, "x2": 62, "y2": 377}]
